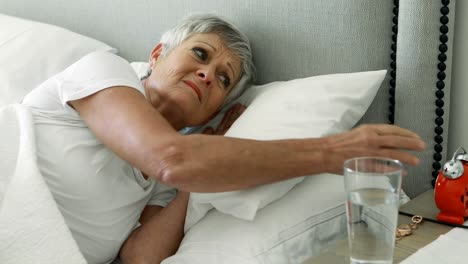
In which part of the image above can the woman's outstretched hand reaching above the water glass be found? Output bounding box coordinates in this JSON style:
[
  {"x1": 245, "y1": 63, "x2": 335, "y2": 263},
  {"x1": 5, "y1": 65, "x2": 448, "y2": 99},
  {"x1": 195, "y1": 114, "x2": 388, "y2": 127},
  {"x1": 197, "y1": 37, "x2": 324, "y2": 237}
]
[{"x1": 324, "y1": 124, "x2": 425, "y2": 174}]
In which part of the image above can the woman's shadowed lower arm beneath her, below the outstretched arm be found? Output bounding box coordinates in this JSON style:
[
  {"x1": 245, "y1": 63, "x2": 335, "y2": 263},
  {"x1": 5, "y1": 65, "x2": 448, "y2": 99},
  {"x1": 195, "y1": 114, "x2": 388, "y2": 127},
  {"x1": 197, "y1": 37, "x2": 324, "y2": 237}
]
[{"x1": 120, "y1": 192, "x2": 189, "y2": 264}]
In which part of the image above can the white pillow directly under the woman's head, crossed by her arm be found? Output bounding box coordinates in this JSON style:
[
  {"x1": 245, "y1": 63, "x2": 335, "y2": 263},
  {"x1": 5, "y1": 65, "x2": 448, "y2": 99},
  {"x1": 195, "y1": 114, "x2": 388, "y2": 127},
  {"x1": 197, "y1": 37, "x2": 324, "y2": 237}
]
[{"x1": 185, "y1": 70, "x2": 386, "y2": 231}]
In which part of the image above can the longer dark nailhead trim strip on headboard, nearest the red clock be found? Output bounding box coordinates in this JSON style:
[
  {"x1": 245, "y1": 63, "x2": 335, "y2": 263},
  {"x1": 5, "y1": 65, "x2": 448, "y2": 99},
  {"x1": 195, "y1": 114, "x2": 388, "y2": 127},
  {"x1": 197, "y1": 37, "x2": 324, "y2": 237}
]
[{"x1": 432, "y1": 0, "x2": 450, "y2": 187}]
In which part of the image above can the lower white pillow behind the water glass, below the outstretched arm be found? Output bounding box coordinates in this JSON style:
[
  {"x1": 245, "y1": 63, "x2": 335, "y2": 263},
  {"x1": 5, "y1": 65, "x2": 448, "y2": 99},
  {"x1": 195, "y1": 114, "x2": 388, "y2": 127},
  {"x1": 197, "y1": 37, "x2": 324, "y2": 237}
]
[{"x1": 162, "y1": 174, "x2": 346, "y2": 264}]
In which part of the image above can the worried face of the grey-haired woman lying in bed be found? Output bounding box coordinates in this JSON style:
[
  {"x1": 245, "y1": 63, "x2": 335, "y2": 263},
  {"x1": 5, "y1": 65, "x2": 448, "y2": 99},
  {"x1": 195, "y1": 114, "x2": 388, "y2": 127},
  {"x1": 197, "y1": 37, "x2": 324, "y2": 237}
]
[{"x1": 145, "y1": 34, "x2": 241, "y2": 129}]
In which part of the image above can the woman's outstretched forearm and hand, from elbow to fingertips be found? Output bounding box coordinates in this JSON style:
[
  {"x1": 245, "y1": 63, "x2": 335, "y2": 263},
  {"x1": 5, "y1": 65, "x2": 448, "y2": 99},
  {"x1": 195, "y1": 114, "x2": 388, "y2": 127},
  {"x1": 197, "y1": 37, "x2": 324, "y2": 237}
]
[{"x1": 161, "y1": 125, "x2": 424, "y2": 192}]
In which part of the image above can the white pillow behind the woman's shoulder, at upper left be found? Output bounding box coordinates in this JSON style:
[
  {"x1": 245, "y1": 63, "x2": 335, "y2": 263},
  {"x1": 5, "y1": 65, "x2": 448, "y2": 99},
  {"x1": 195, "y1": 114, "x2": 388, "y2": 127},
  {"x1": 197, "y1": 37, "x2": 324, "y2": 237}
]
[{"x1": 0, "y1": 14, "x2": 117, "y2": 107}]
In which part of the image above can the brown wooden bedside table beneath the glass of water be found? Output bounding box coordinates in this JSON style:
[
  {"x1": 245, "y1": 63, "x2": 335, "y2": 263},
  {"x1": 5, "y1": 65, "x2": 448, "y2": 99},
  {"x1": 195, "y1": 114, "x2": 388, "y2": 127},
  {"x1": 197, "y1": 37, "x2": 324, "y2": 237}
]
[{"x1": 303, "y1": 189, "x2": 452, "y2": 264}]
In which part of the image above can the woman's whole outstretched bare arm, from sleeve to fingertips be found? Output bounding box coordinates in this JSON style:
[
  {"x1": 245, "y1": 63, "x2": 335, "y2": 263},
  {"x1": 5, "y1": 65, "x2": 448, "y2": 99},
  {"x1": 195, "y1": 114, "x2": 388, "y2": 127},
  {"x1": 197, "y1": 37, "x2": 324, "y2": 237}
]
[{"x1": 70, "y1": 87, "x2": 425, "y2": 192}]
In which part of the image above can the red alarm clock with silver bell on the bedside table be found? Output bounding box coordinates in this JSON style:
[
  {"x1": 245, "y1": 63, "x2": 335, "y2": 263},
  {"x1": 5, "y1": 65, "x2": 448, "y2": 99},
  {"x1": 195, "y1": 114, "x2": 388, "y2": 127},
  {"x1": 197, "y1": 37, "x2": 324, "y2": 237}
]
[{"x1": 434, "y1": 147, "x2": 468, "y2": 225}]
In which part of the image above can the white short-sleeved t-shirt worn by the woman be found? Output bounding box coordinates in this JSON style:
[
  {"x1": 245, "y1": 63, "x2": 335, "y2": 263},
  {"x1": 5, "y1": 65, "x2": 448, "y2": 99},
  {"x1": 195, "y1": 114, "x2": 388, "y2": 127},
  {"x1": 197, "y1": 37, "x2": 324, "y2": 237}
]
[{"x1": 23, "y1": 52, "x2": 175, "y2": 263}]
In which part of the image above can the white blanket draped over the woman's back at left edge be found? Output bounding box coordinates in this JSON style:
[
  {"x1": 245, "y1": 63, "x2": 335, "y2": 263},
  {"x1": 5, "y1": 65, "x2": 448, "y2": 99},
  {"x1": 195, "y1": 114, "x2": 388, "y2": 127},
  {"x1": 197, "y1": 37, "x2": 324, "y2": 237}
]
[{"x1": 0, "y1": 104, "x2": 86, "y2": 264}]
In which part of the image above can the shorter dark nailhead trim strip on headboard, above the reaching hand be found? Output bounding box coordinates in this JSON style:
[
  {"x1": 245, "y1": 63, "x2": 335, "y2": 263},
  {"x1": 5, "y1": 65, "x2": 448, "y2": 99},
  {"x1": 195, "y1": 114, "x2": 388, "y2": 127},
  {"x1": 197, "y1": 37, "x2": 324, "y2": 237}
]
[{"x1": 388, "y1": 0, "x2": 399, "y2": 124}]
